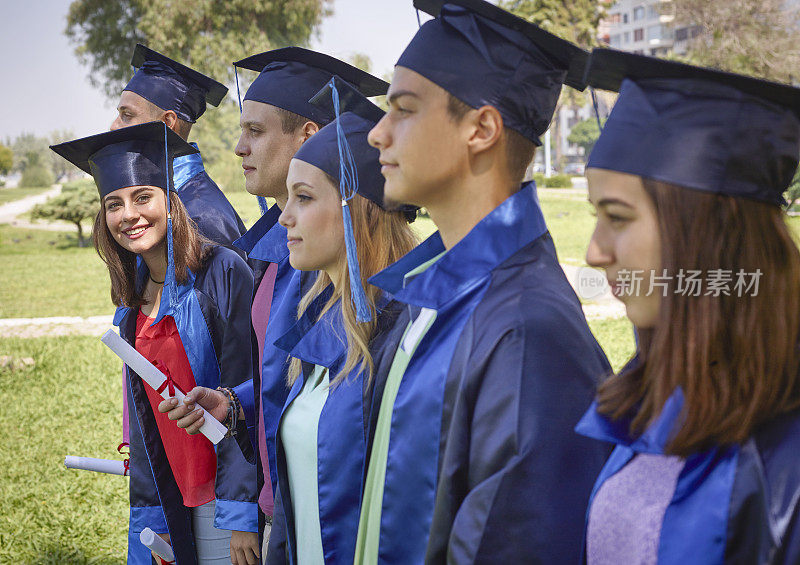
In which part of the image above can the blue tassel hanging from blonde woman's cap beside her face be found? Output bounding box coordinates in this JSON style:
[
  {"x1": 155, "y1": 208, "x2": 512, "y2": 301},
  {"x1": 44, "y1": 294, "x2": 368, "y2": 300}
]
[{"x1": 329, "y1": 79, "x2": 372, "y2": 322}]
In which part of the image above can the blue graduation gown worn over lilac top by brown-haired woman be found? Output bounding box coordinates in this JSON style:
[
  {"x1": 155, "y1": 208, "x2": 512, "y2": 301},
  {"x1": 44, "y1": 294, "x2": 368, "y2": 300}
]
[{"x1": 576, "y1": 390, "x2": 800, "y2": 565}]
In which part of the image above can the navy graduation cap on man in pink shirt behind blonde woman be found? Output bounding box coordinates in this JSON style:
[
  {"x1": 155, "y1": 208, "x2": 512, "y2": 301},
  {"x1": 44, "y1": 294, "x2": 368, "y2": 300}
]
[{"x1": 234, "y1": 47, "x2": 389, "y2": 125}]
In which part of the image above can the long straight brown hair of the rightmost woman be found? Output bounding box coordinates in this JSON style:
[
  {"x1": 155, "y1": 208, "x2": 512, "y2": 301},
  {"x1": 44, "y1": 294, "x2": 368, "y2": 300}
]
[{"x1": 598, "y1": 179, "x2": 800, "y2": 456}]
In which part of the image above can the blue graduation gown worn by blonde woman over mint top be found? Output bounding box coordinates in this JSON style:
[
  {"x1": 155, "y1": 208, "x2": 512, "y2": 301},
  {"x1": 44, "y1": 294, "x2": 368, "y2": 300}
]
[{"x1": 267, "y1": 287, "x2": 399, "y2": 565}]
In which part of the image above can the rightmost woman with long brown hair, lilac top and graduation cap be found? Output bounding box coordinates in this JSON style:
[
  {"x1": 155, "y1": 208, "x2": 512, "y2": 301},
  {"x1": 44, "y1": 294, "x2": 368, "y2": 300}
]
[{"x1": 577, "y1": 50, "x2": 800, "y2": 565}]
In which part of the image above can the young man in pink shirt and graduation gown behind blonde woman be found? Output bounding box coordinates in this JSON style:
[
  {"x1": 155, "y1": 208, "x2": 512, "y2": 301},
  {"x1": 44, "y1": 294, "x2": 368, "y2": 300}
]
[{"x1": 159, "y1": 47, "x2": 389, "y2": 556}]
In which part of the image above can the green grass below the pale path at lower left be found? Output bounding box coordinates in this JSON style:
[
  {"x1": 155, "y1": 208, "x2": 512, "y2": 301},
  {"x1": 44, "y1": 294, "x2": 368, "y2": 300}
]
[{"x1": 0, "y1": 337, "x2": 128, "y2": 565}]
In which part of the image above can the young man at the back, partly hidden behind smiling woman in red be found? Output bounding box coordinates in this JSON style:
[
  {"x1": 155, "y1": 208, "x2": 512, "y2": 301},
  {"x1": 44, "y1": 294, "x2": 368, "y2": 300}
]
[{"x1": 110, "y1": 44, "x2": 245, "y2": 245}]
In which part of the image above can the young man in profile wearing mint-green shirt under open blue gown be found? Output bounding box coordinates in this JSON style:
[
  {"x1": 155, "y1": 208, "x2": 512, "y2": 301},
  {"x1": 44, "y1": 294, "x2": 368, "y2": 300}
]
[{"x1": 355, "y1": 0, "x2": 610, "y2": 564}]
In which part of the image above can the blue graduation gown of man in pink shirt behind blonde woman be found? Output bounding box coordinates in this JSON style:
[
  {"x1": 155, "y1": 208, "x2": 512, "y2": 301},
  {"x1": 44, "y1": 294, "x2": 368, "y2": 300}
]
[{"x1": 234, "y1": 205, "x2": 302, "y2": 494}]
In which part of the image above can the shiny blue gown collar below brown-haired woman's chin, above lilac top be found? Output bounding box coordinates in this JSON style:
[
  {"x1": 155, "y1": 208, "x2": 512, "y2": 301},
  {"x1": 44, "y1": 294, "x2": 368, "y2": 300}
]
[{"x1": 575, "y1": 388, "x2": 684, "y2": 455}]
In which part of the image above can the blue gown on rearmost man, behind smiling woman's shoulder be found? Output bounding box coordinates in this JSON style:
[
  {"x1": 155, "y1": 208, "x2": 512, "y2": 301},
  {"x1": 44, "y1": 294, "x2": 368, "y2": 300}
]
[{"x1": 172, "y1": 147, "x2": 245, "y2": 245}]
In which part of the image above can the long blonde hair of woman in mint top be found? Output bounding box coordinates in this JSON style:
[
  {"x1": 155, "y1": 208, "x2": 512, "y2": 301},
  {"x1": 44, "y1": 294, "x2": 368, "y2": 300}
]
[{"x1": 287, "y1": 192, "x2": 417, "y2": 387}]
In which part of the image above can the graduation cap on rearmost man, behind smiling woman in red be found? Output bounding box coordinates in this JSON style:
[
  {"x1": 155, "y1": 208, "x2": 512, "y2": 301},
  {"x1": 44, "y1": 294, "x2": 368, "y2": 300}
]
[{"x1": 124, "y1": 43, "x2": 228, "y2": 123}]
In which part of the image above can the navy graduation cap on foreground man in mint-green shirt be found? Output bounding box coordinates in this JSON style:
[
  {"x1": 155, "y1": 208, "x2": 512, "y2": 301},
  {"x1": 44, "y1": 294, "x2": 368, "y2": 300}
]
[{"x1": 397, "y1": 0, "x2": 587, "y2": 145}]
